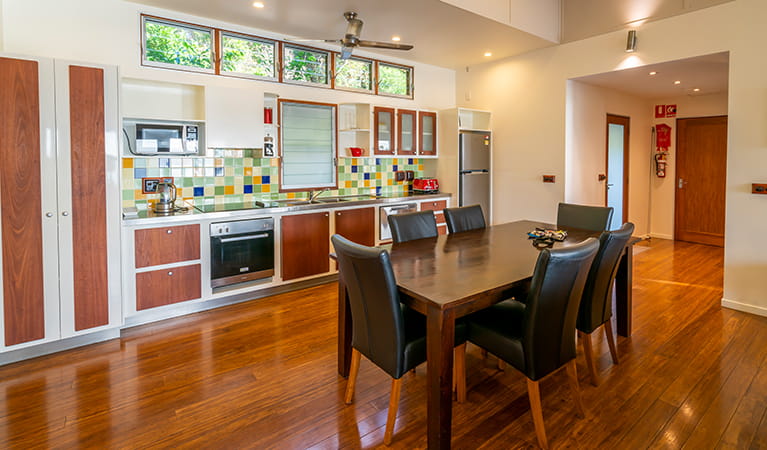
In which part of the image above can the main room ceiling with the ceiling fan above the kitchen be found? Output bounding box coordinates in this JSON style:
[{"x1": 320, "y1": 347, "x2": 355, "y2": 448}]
[{"x1": 127, "y1": 0, "x2": 554, "y2": 68}]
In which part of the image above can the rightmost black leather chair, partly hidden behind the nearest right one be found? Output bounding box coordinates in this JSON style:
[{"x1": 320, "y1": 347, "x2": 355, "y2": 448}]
[{"x1": 575, "y1": 222, "x2": 634, "y2": 386}]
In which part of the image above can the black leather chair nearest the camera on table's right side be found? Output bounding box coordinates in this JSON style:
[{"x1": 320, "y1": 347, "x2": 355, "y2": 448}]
[{"x1": 466, "y1": 238, "x2": 599, "y2": 448}]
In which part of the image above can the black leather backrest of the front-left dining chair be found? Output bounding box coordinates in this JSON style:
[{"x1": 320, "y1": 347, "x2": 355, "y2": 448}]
[{"x1": 331, "y1": 234, "x2": 412, "y2": 378}]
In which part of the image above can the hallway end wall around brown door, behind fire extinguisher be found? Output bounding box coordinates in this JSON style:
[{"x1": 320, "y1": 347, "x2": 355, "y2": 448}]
[{"x1": 650, "y1": 93, "x2": 727, "y2": 239}]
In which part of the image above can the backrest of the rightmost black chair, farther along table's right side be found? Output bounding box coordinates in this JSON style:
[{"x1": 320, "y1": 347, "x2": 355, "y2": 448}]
[{"x1": 576, "y1": 222, "x2": 634, "y2": 333}]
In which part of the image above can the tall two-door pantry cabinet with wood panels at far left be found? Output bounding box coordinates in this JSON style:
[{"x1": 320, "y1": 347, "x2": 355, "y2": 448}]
[{"x1": 0, "y1": 55, "x2": 122, "y2": 351}]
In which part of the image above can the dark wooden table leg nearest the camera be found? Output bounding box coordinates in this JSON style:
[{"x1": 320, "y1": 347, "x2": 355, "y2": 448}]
[{"x1": 426, "y1": 307, "x2": 455, "y2": 449}]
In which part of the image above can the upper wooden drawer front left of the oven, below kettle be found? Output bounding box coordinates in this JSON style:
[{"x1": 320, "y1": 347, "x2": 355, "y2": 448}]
[{"x1": 135, "y1": 225, "x2": 200, "y2": 267}]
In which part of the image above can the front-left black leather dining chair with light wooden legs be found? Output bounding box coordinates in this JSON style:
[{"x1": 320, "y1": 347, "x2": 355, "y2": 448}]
[{"x1": 331, "y1": 234, "x2": 466, "y2": 445}]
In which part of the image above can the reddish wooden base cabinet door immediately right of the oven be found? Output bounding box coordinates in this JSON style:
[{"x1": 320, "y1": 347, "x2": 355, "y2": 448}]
[{"x1": 281, "y1": 212, "x2": 330, "y2": 280}]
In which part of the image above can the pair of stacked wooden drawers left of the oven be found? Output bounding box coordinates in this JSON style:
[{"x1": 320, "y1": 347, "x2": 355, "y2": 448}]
[{"x1": 133, "y1": 224, "x2": 202, "y2": 311}]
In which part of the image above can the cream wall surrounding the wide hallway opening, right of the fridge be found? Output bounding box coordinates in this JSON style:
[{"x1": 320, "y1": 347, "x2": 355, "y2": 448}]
[{"x1": 456, "y1": 0, "x2": 767, "y2": 315}]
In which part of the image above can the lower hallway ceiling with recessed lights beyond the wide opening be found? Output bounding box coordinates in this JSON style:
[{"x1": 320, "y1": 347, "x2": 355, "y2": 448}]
[{"x1": 575, "y1": 52, "x2": 730, "y2": 100}]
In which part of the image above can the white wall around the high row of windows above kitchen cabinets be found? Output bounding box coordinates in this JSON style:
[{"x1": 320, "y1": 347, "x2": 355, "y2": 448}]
[{"x1": 0, "y1": 0, "x2": 455, "y2": 110}]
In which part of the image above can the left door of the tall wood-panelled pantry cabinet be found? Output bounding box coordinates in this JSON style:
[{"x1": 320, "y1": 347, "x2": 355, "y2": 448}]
[{"x1": 0, "y1": 55, "x2": 59, "y2": 348}]
